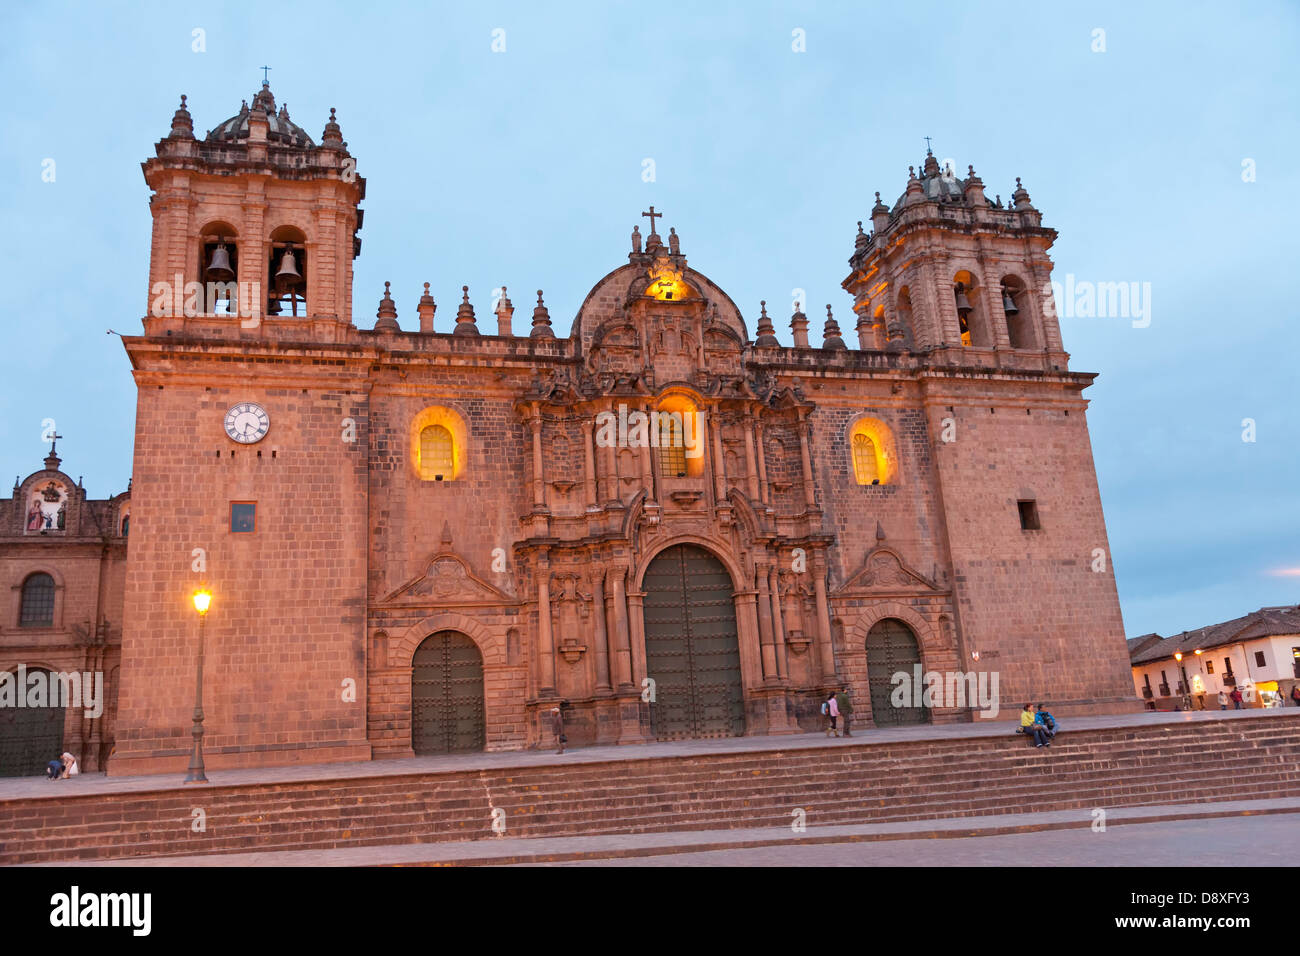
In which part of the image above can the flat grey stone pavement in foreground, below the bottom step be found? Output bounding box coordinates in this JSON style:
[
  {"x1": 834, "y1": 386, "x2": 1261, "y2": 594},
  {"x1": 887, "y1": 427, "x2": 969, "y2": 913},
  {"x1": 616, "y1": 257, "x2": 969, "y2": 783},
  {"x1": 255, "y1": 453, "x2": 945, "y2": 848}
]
[{"x1": 22, "y1": 797, "x2": 1300, "y2": 866}]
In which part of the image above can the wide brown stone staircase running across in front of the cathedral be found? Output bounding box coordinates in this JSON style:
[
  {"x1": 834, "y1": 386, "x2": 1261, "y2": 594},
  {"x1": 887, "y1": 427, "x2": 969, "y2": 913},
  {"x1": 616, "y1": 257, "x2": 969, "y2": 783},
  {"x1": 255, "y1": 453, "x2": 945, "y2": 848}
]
[{"x1": 0, "y1": 710, "x2": 1300, "y2": 864}]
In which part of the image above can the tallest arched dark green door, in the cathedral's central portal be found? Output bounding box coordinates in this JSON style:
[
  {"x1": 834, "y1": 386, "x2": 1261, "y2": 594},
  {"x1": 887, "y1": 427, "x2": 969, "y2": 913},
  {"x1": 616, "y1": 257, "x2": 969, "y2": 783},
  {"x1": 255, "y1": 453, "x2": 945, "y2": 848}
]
[{"x1": 641, "y1": 545, "x2": 745, "y2": 740}]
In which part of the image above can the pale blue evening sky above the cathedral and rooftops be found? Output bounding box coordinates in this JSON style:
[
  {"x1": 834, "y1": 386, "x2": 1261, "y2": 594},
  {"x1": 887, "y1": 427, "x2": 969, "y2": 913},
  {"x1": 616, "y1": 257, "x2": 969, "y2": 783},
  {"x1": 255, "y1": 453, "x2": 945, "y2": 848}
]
[{"x1": 0, "y1": 1, "x2": 1300, "y2": 635}]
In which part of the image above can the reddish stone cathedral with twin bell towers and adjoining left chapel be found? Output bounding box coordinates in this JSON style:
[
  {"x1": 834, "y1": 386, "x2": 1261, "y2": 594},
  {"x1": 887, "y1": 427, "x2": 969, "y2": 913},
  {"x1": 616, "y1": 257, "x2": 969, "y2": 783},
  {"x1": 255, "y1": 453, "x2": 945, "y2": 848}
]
[{"x1": 0, "y1": 85, "x2": 1139, "y2": 775}]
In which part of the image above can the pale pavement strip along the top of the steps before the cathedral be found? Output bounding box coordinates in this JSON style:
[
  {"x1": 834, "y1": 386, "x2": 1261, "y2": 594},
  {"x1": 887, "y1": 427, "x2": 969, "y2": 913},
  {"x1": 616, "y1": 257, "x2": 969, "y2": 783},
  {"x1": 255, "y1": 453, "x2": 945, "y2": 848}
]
[{"x1": 0, "y1": 708, "x2": 1300, "y2": 800}]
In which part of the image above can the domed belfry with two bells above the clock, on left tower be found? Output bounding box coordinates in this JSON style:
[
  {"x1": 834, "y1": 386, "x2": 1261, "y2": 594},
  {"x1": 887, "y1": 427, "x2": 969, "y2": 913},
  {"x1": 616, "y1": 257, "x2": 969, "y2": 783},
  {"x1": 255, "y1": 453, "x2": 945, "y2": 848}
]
[{"x1": 142, "y1": 82, "x2": 365, "y2": 342}]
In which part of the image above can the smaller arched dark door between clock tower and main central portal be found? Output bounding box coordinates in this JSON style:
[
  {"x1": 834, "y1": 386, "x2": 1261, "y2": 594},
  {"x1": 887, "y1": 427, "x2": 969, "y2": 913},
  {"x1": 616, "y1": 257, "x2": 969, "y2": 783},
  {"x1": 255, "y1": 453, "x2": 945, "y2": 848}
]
[{"x1": 411, "y1": 631, "x2": 486, "y2": 753}]
